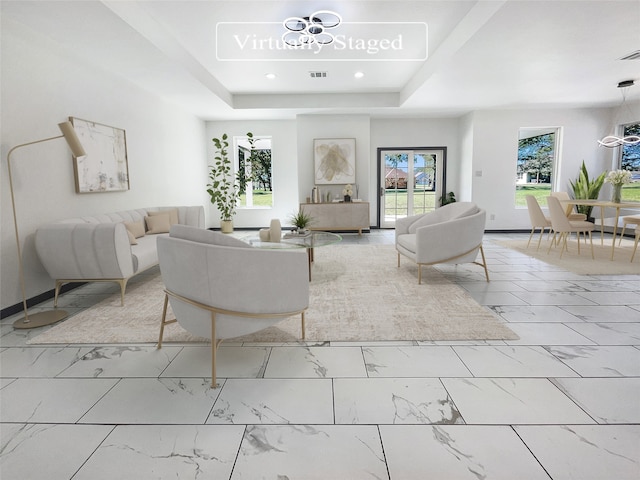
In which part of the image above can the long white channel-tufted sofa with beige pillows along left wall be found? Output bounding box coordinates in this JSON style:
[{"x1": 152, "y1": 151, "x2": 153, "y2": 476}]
[{"x1": 35, "y1": 206, "x2": 204, "y2": 306}]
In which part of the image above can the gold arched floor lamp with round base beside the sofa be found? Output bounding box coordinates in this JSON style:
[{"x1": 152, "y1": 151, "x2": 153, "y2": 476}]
[{"x1": 7, "y1": 122, "x2": 86, "y2": 328}]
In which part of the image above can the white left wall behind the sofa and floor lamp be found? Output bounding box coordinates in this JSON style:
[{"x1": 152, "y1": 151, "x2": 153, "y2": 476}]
[{"x1": 0, "y1": 18, "x2": 208, "y2": 308}]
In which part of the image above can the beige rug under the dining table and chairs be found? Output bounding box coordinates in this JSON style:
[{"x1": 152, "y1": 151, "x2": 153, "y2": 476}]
[{"x1": 495, "y1": 238, "x2": 640, "y2": 275}]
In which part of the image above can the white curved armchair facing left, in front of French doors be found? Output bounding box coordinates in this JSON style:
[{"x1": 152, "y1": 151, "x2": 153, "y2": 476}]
[{"x1": 395, "y1": 202, "x2": 489, "y2": 283}]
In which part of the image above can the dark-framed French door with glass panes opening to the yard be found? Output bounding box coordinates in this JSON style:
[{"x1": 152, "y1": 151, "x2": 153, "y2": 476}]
[{"x1": 378, "y1": 147, "x2": 446, "y2": 228}]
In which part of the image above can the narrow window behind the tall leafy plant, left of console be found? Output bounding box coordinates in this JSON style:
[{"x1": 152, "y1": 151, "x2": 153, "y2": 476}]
[{"x1": 235, "y1": 134, "x2": 273, "y2": 208}]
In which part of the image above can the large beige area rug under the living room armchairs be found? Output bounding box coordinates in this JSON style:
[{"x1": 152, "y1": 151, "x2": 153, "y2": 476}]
[{"x1": 29, "y1": 245, "x2": 518, "y2": 344}]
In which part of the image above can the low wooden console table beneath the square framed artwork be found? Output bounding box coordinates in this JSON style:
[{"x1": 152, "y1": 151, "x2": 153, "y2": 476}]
[{"x1": 300, "y1": 202, "x2": 371, "y2": 235}]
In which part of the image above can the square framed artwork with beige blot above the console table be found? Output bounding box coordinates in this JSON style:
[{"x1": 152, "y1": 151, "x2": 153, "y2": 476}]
[{"x1": 313, "y1": 138, "x2": 356, "y2": 185}]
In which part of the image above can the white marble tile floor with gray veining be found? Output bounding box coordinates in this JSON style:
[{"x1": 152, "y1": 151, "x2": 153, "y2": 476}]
[{"x1": 0, "y1": 230, "x2": 640, "y2": 480}]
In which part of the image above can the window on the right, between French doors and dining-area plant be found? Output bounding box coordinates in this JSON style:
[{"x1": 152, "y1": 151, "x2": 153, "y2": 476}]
[{"x1": 515, "y1": 127, "x2": 558, "y2": 207}]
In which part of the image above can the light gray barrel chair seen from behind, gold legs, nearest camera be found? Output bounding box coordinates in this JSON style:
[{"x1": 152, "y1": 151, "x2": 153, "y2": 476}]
[{"x1": 158, "y1": 225, "x2": 309, "y2": 388}]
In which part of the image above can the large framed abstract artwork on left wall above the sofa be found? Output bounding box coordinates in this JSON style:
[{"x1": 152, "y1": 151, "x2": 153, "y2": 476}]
[{"x1": 69, "y1": 117, "x2": 129, "y2": 193}]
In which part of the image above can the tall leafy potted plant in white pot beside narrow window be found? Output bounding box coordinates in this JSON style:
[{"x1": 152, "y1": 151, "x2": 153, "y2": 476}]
[{"x1": 207, "y1": 133, "x2": 240, "y2": 233}]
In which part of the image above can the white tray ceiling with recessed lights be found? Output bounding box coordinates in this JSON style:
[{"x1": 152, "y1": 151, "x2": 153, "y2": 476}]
[{"x1": 1, "y1": 0, "x2": 640, "y2": 120}]
